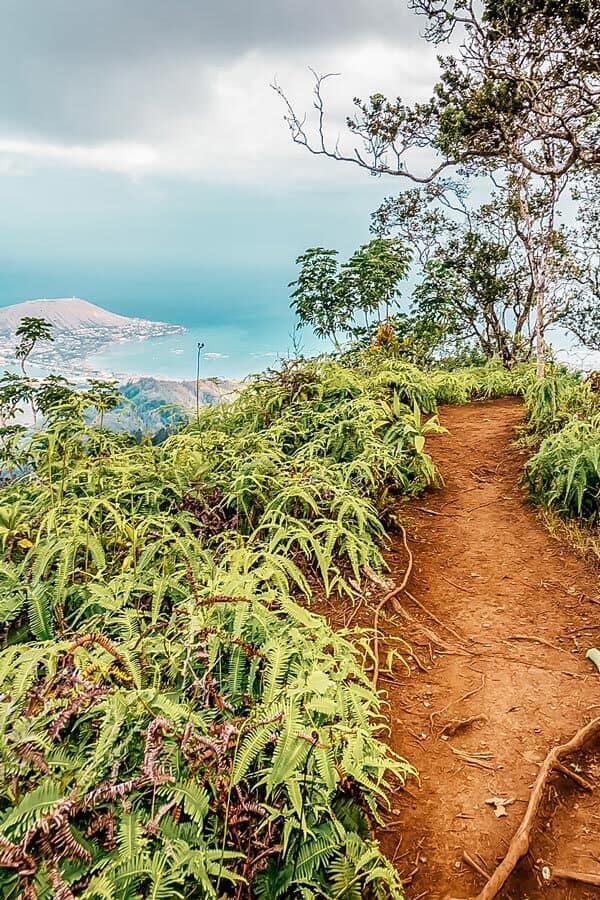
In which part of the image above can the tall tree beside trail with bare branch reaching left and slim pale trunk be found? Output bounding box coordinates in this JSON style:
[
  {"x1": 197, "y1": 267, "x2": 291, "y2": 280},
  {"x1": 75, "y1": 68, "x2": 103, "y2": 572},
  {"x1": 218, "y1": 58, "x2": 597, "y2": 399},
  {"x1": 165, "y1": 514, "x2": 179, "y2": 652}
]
[{"x1": 274, "y1": 0, "x2": 600, "y2": 375}]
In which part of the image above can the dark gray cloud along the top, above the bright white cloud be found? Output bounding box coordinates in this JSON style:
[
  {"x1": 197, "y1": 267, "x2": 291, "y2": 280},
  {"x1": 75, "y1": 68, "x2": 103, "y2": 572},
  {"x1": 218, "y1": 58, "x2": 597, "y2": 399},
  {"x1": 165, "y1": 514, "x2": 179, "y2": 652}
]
[{"x1": 0, "y1": 0, "x2": 419, "y2": 142}]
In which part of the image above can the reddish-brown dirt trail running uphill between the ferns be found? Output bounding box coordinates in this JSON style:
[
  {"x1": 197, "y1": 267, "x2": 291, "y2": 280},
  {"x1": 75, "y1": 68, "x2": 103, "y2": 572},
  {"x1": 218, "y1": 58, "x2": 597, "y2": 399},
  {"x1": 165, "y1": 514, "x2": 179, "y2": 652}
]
[{"x1": 376, "y1": 400, "x2": 600, "y2": 900}]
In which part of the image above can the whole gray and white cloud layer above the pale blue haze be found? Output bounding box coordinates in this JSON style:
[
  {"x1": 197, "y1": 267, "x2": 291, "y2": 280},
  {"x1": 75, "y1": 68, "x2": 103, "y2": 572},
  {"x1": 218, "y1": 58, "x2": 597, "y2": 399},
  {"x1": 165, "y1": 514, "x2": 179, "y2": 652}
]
[{"x1": 0, "y1": 0, "x2": 436, "y2": 183}]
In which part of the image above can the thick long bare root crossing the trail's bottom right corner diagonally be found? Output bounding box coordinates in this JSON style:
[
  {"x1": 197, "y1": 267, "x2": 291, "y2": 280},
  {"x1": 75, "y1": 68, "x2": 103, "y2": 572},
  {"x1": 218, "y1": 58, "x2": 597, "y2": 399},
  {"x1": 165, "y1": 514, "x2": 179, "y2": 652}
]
[{"x1": 466, "y1": 717, "x2": 600, "y2": 900}]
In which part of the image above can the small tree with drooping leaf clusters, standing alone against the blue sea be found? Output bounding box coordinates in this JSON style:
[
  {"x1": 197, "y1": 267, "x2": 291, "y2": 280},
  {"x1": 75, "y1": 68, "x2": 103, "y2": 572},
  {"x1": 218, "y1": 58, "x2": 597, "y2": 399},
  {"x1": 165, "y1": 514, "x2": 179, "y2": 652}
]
[{"x1": 289, "y1": 236, "x2": 411, "y2": 350}]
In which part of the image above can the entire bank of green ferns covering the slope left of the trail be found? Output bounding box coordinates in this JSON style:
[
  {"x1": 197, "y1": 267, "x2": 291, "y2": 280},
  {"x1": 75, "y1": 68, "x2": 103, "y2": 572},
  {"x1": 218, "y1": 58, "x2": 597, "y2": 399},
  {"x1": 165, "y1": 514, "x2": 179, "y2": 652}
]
[{"x1": 0, "y1": 355, "x2": 438, "y2": 900}]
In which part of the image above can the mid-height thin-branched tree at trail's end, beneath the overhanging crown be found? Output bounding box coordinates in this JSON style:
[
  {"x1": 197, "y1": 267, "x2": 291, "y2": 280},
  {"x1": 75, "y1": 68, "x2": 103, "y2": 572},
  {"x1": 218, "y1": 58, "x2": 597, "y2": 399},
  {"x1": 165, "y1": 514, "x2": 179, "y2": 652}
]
[{"x1": 373, "y1": 178, "x2": 579, "y2": 365}]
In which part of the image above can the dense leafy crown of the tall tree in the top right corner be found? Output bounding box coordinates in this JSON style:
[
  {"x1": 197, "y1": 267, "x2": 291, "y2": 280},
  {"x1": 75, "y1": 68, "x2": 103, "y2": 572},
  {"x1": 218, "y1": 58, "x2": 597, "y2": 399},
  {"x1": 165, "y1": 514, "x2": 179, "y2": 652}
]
[{"x1": 413, "y1": 0, "x2": 600, "y2": 178}]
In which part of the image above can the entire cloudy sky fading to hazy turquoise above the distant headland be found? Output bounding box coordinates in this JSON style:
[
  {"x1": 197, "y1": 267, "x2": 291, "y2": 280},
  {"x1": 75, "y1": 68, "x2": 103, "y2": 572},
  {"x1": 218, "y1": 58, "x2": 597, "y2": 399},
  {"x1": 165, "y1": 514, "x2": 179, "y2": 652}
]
[{"x1": 0, "y1": 0, "x2": 436, "y2": 362}]
